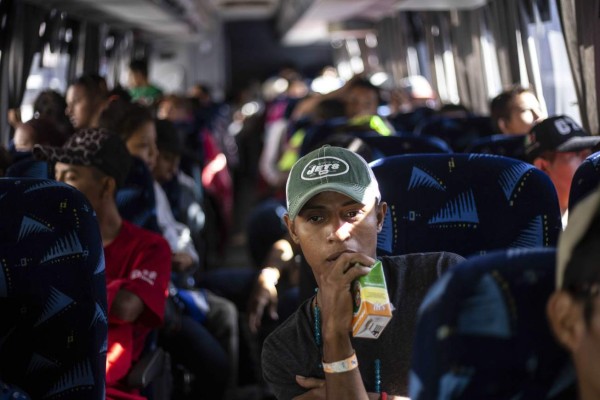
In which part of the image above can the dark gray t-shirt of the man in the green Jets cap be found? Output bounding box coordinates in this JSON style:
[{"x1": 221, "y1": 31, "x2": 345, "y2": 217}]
[{"x1": 262, "y1": 253, "x2": 463, "y2": 400}]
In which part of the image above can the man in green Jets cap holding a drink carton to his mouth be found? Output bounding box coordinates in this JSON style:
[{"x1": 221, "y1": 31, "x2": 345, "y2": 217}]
[{"x1": 262, "y1": 146, "x2": 462, "y2": 399}]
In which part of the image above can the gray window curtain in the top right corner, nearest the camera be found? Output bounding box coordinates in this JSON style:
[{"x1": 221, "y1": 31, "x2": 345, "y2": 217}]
[{"x1": 559, "y1": 0, "x2": 600, "y2": 135}]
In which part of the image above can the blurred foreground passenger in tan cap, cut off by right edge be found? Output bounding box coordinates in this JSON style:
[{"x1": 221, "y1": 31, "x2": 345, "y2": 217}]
[{"x1": 547, "y1": 184, "x2": 600, "y2": 400}]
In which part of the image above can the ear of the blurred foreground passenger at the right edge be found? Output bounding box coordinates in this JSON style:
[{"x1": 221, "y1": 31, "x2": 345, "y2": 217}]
[{"x1": 546, "y1": 290, "x2": 586, "y2": 353}]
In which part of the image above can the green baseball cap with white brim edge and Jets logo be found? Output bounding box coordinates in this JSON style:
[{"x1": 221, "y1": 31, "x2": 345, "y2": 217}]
[{"x1": 286, "y1": 145, "x2": 381, "y2": 220}]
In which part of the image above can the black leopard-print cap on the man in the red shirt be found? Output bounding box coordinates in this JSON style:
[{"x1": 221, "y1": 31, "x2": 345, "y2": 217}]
[{"x1": 33, "y1": 128, "x2": 132, "y2": 187}]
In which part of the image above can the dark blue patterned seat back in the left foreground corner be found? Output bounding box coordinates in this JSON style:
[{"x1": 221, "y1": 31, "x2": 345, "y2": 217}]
[{"x1": 0, "y1": 178, "x2": 107, "y2": 400}]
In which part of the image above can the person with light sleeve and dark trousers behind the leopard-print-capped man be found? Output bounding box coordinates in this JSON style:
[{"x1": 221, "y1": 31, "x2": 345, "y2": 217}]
[{"x1": 101, "y1": 101, "x2": 238, "y2": 399}]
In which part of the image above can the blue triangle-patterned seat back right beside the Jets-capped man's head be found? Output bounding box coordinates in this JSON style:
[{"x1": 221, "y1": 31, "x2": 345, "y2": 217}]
[{"x1": 371, "y1": 154, "x2": 561, "y2": 257}]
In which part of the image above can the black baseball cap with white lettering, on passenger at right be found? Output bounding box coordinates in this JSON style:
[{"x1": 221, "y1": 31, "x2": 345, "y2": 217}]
[{"x1": 525, "y1": 115, "x2": 600, "y2": 161}]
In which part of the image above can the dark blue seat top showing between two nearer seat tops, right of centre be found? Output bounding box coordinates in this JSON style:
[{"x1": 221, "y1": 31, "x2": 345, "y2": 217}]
[{"x1": 415, "y1": 117, "x2": 494, "y2": 152}]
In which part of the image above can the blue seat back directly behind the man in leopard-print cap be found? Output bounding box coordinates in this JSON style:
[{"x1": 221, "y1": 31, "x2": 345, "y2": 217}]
[{"x1": 116, "y1": 157, "x2": 161, "y2": 233}]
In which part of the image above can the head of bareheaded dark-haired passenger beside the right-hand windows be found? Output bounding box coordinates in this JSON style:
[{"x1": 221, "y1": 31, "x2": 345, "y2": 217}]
[{"x1": 490, "y1": 86, "x2": 548, "y2": 135}]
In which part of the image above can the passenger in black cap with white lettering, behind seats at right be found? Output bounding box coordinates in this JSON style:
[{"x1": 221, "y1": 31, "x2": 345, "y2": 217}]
[{"x1": 525, "y1": 116, "x2": 600, "y2": 228}]
